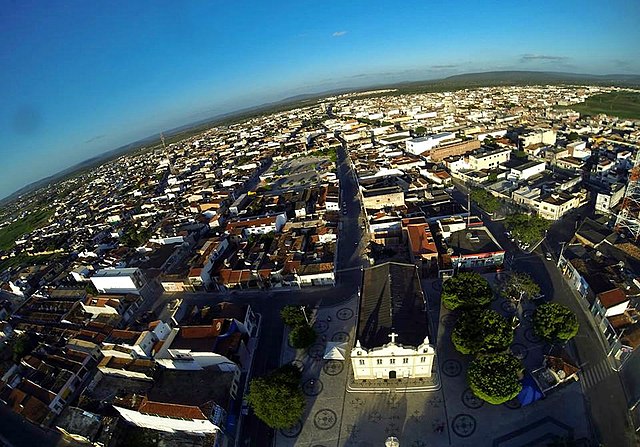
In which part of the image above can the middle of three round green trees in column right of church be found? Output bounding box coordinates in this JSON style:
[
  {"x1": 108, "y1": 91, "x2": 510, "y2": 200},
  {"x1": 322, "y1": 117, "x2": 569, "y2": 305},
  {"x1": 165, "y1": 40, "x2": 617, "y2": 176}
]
[{"x1": 451, "y1": 309, "x2": 513, "y2": 354}]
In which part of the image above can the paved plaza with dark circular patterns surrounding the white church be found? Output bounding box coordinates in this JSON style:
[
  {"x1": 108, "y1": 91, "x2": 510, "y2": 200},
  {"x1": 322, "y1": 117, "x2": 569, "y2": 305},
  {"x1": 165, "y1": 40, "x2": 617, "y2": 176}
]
[{"x1": 275, "y1": 277, "x2": 589, "y2": 447}]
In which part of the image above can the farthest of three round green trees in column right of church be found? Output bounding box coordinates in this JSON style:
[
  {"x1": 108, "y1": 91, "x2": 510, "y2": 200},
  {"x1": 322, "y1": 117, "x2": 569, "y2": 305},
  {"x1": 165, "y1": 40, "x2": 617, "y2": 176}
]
[{"x1": 442, "y1": 272, "x2": 493, "y2": 310}]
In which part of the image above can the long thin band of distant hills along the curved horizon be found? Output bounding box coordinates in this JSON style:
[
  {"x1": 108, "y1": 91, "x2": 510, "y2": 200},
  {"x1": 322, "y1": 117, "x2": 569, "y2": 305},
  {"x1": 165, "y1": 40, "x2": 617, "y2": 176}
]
[{"x1": 0, "y1": 71, "x2": 640, "y2": 205}]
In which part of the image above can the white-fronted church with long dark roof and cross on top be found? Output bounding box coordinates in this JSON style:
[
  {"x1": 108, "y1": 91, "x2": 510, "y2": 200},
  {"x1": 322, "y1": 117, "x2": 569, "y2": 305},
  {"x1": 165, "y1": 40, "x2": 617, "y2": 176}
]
[{"x1": 351, "y1": 262, "x2": 435, "y2": 380}]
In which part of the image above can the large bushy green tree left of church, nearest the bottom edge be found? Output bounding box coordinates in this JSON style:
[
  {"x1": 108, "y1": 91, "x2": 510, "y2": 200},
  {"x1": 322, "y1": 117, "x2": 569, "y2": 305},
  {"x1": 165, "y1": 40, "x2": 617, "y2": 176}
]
[{"x1": 247, "y1": 365, "x2": 305, "y2": 429}]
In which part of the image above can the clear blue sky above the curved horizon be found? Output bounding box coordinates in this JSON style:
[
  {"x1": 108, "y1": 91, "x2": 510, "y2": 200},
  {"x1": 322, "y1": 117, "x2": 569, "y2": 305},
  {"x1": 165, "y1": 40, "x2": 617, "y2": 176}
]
[{"x1": 0, "y1": 0, "x2": 640, "y2": 197}]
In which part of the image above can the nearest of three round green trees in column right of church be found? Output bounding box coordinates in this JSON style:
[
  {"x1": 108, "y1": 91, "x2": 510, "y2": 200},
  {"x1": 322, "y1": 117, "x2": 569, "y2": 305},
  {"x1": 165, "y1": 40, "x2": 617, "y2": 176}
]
[{"x1": 467, "y1": 354, "x2": 522, "y2": 405}]
